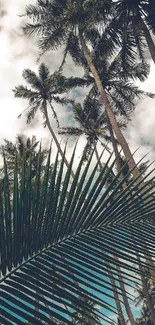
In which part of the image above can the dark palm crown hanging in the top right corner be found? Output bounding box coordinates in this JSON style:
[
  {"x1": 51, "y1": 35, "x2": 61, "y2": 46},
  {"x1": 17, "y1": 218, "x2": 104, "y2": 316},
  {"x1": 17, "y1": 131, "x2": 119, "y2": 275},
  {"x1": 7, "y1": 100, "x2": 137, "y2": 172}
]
[{"x1": 111, "y1": 0, "x2": 155, "y2": 64}]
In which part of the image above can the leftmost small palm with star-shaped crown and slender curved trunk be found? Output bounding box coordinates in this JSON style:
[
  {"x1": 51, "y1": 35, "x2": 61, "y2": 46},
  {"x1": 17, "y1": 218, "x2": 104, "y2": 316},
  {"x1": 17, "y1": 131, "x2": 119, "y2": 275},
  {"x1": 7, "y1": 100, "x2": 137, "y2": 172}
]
[{"x1": 13, "y1": 63, "x2": 90, "y2": 177}]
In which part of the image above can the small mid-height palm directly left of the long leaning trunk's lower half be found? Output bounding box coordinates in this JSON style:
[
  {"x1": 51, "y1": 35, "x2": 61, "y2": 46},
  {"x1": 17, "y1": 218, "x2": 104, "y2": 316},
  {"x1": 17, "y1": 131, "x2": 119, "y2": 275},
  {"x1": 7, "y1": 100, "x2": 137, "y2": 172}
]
[{"x1": 59, "y1": 96, "x2": 125, "y2": 190}]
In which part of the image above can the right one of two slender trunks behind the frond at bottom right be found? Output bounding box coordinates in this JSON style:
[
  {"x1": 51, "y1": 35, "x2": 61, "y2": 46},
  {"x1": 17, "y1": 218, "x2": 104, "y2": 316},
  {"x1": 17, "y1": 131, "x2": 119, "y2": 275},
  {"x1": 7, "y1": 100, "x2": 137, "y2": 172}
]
[{"x1": 115, "y1": 264, "x2": 136, "y2": 325}]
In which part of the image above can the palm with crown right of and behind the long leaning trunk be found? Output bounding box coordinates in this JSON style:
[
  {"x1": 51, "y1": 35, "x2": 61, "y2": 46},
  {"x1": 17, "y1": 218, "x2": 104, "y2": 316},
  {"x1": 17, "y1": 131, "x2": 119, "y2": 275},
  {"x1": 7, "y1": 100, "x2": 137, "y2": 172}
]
[{"x1": 81, "y1": 44, "x2": 154, "y2": 175}]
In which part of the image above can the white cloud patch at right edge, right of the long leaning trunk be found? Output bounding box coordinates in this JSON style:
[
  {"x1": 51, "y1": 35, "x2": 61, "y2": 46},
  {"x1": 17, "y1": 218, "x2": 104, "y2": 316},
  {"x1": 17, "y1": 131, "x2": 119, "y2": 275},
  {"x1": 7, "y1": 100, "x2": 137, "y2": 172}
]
[{"x1": 127, "y1": 63, "x2": 155, "y2": 165}]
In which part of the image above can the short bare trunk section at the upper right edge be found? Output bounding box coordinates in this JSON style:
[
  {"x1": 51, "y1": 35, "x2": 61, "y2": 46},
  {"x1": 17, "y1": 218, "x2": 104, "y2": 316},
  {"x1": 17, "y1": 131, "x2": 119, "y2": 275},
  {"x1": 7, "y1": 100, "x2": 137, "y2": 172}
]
[{"x1": 138, "y1": 17, "x2": 155, "y2": 63}]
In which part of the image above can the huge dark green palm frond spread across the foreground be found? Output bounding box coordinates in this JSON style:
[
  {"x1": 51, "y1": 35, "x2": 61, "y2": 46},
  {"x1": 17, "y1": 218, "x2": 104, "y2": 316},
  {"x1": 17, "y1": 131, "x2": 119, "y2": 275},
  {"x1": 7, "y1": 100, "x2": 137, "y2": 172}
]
[{"x1": 0, "y1": 146, "x2": 155, "y2": 324}]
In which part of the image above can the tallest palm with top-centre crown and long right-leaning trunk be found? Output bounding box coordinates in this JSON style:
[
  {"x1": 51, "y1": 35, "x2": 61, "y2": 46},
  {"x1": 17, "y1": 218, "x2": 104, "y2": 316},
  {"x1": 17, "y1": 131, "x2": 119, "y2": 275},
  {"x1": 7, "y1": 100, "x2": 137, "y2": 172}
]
[{"x1": 25, "y1": 0, "x2": 153, "y2": 187}]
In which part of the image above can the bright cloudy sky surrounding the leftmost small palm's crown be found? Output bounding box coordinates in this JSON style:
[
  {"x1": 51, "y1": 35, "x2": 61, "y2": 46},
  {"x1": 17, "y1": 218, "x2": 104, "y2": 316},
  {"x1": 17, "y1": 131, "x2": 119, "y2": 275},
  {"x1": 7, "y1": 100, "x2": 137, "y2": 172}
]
[{"x1": 0, "y1": 0, "x2": 87, "y2": 165}]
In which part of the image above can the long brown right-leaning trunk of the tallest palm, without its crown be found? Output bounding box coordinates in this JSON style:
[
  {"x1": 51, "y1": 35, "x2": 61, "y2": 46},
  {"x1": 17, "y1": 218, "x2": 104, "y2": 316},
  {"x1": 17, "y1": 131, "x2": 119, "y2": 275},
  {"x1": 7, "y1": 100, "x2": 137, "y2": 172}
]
[{"x1": 79, "y1": 32, "x2": 142, "y2": 187}]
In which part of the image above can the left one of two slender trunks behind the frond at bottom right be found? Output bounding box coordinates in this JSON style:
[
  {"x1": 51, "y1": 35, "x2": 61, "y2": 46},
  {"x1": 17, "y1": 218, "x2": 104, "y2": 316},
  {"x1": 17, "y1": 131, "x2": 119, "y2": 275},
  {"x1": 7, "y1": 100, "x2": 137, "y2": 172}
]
[{"x1": 106, "y1": 263, "x2": 126, "y2": 325}]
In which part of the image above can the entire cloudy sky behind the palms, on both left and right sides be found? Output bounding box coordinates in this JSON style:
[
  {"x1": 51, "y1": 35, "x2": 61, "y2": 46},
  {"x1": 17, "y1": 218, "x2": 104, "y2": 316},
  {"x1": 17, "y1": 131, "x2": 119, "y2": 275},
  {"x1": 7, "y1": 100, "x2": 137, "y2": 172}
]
[{"x1": 0, "y1": 0, "x2": 155, "y2": 322}]
